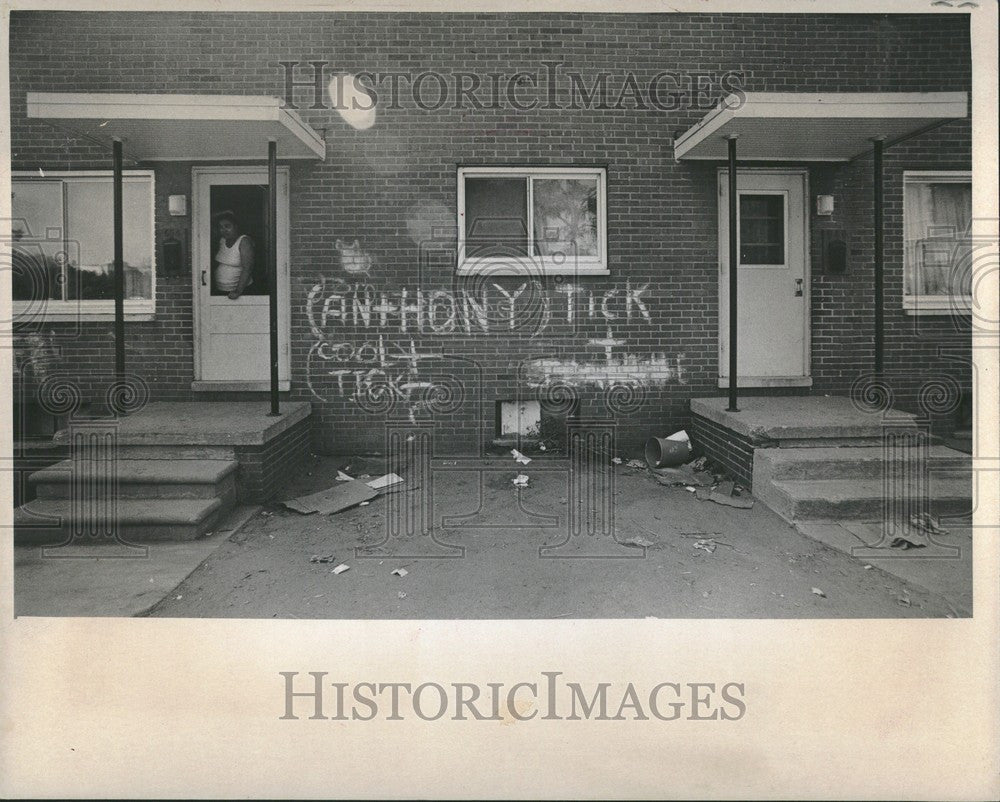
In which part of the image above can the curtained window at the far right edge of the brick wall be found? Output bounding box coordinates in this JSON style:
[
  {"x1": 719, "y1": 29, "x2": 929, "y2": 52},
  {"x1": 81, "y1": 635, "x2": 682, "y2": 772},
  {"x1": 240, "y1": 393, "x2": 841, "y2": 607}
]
[{"x1": 903, "y1": 172, "x2": 972, "y2": 314}]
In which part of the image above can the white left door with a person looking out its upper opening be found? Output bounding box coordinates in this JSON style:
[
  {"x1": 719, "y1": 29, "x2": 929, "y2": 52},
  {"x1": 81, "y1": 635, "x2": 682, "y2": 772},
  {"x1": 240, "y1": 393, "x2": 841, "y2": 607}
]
[{"x1": 191, "y1": 167, "x2": 289, "y2": 390}]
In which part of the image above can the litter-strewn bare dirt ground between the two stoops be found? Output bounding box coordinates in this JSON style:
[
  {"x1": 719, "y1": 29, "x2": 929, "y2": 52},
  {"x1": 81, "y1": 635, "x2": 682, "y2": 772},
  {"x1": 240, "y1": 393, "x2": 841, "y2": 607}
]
[{"x1": 143, "y1": 450, "x2": 958, "y2": 619}]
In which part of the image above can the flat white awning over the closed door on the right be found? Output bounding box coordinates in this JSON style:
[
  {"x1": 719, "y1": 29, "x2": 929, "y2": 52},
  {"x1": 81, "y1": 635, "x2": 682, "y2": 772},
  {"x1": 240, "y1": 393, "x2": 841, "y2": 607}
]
[{"x1": 674, "y1": 92, "x2": 968, "y2": 162}]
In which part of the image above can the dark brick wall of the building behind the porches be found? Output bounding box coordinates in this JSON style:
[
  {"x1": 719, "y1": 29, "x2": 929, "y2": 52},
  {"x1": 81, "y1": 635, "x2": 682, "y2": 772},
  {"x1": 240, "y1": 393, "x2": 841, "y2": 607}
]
[{"x1": 11, "y1": 12, "x2": 971, "y2": 453}]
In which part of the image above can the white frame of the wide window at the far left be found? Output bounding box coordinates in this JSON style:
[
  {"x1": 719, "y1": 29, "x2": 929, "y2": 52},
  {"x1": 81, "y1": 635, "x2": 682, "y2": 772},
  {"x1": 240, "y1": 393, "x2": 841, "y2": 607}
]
[{"x1": 11, "y1": 170, "x2": 157, "y2": 324}]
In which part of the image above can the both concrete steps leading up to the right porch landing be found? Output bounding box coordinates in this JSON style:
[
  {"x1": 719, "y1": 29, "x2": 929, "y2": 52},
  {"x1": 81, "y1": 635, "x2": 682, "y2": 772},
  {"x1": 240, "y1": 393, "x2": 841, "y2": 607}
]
[{"x1": 753, "y1": 445, "x2": 972, "y2": 523}]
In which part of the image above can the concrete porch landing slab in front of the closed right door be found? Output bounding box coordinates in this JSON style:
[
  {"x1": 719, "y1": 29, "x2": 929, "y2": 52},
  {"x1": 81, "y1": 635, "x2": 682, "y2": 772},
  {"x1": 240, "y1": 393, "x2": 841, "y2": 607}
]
[{"x1": 691, "y1": 395, "x2": 915, "y2": 446}]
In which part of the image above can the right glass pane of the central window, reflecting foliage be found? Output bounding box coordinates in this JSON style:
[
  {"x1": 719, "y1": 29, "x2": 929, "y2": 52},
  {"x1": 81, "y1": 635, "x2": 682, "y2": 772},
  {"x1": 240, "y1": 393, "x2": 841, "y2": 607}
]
[{"x1": 531, "y1": 178, "x2": 598, "y2": 257}]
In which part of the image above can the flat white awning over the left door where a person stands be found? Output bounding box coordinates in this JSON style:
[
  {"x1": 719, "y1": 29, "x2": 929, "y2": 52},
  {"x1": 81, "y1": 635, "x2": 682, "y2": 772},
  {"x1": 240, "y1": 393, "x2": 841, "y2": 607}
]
[{"x1": 28, "y1": 92, "x2": 326, "y2": 161}]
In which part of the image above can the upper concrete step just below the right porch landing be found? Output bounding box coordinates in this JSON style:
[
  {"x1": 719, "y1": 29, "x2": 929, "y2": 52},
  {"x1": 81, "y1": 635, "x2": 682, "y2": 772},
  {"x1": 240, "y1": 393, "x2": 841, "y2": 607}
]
[{"x1": 753, "y1": 446, "x2": 972, "y2": 487}]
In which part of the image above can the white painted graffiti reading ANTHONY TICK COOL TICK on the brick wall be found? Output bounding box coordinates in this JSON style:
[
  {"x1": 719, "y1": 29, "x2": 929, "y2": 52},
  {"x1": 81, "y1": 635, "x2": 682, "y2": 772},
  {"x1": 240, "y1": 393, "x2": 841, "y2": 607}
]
[{"x1": 306, "y1": 279, "x2": 686, "y2": 419}]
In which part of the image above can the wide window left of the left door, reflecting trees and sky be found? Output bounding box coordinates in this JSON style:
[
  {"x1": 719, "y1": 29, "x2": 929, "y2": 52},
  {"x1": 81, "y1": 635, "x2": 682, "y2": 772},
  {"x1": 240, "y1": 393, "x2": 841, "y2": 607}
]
[{"x1": 11, "y1": 170, "x2": 155, "y2": 320}]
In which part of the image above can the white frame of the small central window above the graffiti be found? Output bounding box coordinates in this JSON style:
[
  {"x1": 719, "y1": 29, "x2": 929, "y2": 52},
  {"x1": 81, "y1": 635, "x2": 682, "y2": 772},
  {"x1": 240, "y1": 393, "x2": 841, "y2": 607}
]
[{"x1": 456, "y1": 165, "x2": 610, "y2": 276}]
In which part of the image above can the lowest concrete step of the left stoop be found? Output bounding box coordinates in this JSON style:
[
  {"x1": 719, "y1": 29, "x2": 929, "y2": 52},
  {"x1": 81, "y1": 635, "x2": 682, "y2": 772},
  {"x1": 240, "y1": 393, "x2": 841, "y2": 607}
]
[{"x1": 14, "y1": 498, "x2": 227, "y2": 545}]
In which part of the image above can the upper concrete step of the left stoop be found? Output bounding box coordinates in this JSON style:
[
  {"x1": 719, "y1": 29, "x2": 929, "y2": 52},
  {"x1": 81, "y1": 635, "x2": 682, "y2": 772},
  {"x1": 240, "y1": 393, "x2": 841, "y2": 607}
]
[{"x1": 28, "y1": 459, "x2": 237, "y2": 499}]
